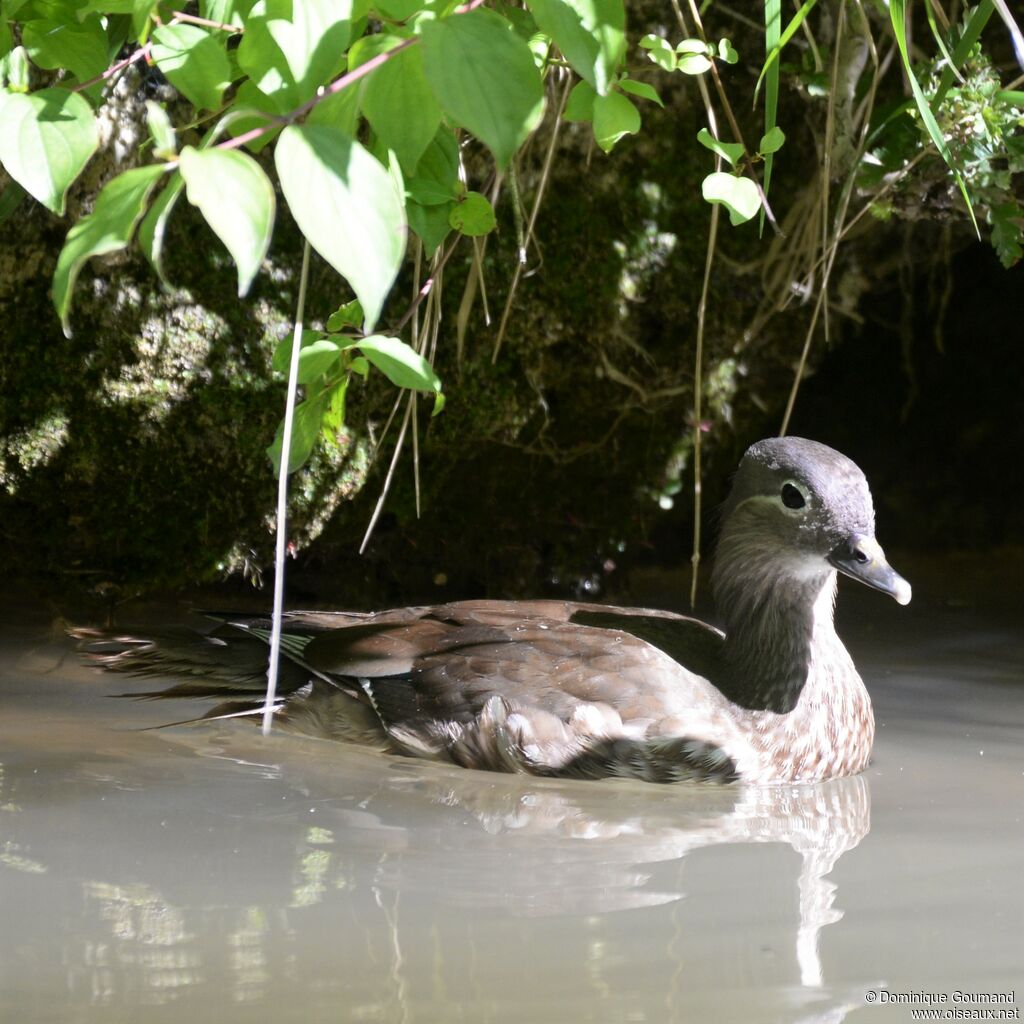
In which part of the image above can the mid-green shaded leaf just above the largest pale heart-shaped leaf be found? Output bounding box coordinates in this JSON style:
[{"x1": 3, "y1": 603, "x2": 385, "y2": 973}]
[{"x1": 344, "y1": 35, "x2": 441, "y2": 173}]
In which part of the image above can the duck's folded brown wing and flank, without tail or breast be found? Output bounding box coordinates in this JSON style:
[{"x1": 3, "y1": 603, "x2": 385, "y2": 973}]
[{"x1": 302, "y1": 601, "x2": 733, "y2": 781}]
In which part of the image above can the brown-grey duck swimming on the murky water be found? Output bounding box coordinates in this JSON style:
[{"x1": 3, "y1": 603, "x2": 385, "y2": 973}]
[{"x1": 83, "y1": 438, "x2": 909, "y2": 782}]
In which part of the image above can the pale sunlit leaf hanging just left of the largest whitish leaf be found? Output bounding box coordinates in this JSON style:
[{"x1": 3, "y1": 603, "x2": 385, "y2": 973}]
[{"x1": 178, "y1": 145, "x2": 274, "y2": 298}]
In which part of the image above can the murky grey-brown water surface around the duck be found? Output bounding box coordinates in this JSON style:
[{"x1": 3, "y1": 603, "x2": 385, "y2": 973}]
[{"x1": 0, "y1": 573, "x2": 1024, "y2": 1024}]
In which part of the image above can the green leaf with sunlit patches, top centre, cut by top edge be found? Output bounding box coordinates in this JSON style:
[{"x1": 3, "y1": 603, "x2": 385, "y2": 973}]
[{"x1": 529, "y1": 0, "x2": 626, "y2": 96}]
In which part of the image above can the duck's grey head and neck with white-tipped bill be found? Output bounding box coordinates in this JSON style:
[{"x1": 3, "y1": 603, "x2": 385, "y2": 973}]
[{"x1": 712, "y1": 437, "x2": 910, "y2": 713}]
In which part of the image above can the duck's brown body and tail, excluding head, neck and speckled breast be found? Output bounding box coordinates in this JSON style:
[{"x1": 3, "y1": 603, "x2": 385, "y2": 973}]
[{"x1": 79, "y1": 601, "x2": 734, "y2": 781}]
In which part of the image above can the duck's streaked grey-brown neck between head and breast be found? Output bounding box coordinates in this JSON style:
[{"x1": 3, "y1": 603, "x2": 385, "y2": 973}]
[{"x1": 713, "y1": 537, "x2": 842, "y2": 715}]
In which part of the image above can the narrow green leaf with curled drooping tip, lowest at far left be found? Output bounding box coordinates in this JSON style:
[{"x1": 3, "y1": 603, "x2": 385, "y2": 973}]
[{"x1": 52, "y1": 163, "x2": 164, "y2": 337}]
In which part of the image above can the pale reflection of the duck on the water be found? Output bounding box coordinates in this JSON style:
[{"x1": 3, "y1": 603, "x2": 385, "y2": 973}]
[{"x1": 188, "y1": 741, "x2": 872, "y2": 1021}]
